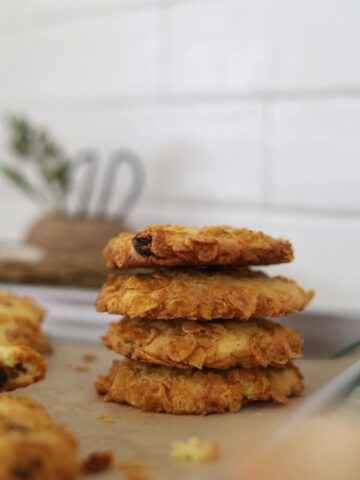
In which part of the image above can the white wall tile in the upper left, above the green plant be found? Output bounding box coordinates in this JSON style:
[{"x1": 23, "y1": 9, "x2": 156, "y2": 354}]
[{"x1": 0, "y1": 9, "x2": 159, "y2": 98}]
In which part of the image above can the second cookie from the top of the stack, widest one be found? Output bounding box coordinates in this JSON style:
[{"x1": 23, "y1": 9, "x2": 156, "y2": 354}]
[{"x1": 96, "y1": 268, "x2": 314, "y2": 320}]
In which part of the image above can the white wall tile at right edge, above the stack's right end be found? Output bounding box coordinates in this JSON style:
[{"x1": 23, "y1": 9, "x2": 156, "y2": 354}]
[{"x1": 268, "y1": 97, "x2": 360, "y2": 212}]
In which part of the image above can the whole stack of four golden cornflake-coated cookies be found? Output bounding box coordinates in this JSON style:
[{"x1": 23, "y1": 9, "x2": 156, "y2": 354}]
[{"x1": 95, "y1": 225, "x2": 313, "y2": 415}]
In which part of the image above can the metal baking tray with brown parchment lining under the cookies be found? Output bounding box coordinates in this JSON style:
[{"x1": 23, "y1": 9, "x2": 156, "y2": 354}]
[{"x1": 0, "y1": 285, "x2": 360, "y2": 480}]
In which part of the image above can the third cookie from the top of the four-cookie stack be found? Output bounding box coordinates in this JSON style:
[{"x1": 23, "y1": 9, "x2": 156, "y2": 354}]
[{"x1": 103, "y1": 318, "x2": 303, "y2": 369}]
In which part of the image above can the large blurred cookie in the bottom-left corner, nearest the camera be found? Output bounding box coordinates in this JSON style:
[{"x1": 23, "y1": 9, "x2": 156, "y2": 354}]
[{"x1": 0, "y1": 394, "x2": 79, "y2": 480}]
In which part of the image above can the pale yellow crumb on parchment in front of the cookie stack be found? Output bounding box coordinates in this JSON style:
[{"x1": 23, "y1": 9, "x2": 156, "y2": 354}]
[{"x1": 171, "y1": 437, "x2": 219, "y2": 462}]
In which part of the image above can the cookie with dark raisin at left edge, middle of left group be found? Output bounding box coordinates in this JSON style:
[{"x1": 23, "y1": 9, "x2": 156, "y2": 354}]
[{"x1": 0, "y1": 345, "x2": 47, "y2": 392}]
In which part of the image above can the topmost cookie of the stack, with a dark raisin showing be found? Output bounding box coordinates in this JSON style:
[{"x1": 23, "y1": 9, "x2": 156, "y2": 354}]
[{"x1": 104, "y1": 225, "x2": 293, "y2": 268}]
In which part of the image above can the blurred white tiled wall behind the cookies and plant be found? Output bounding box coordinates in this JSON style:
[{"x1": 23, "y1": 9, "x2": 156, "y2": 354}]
[{"x1": 0, "y1": 0, "x2": 360, "y2": 310}]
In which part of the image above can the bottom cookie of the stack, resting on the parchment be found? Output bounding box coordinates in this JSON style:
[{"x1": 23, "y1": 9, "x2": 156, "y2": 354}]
[{"x1": 95, "y1": 360, "x2": 303, "y2": 415}]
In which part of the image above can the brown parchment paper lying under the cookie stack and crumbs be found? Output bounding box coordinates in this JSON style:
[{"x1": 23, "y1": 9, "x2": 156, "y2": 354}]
[{"x1": 19, "y1": 342, "x2": 354, "y2": 480}]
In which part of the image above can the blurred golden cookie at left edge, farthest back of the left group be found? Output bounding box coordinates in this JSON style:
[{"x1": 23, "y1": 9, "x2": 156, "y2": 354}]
[{"x1": 0, "y1": 291, "x2": 51, "y2": 353}]
